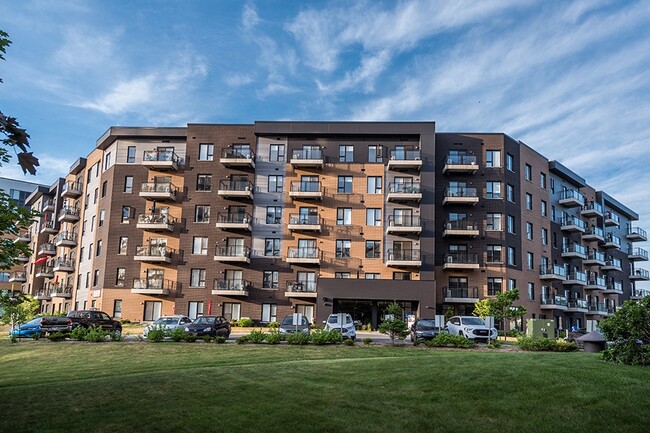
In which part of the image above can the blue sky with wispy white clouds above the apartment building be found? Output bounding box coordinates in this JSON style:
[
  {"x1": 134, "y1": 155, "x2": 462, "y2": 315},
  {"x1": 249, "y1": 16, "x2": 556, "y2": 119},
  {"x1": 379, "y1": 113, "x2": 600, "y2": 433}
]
[{"x1": 0, "y1": 0, "x2": 650, "y2": 230}]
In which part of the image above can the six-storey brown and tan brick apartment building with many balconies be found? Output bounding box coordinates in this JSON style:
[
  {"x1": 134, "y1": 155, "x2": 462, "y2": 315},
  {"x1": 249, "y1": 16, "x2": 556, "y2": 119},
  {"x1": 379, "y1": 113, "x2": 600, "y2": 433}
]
[{"x1": 17, "y1": 122, "x2": 650, "y2": 329}]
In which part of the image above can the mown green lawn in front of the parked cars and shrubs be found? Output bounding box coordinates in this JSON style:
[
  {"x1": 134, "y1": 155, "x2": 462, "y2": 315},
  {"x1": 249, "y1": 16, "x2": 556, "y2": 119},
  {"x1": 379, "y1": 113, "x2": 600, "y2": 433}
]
[{"x1": 0, "y1": 341, "x2": 650, "y2": 433}]
